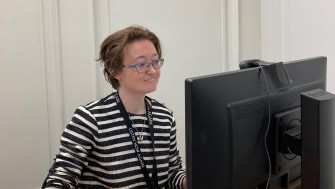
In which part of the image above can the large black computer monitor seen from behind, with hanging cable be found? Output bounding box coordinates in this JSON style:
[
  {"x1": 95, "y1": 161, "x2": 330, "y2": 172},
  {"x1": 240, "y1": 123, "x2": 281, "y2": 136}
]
[{"x1": 185, "y1": 57, "x2": 327, "y2": 189}]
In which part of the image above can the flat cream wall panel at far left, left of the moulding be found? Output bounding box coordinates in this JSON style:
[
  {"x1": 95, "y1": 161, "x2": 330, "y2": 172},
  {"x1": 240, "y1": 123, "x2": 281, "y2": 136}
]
[{"x1": 0, "y1": 1, "x2": 49, "y2": 188}]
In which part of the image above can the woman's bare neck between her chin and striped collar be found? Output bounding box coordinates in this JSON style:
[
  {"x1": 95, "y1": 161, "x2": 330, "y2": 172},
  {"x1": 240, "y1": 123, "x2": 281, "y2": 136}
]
[{"x1": 118, "y1": 89, "x2": 146, "y2": 114}]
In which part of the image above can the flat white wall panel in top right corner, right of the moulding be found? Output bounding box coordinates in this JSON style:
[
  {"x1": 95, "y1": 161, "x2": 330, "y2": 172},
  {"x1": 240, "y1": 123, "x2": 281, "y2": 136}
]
[{"x1": 289, "y1": 0, "x2": 335, "y2": 94}]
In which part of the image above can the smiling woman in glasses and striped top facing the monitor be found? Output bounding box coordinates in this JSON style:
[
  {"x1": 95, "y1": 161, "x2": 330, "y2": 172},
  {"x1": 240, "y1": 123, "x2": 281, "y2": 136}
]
[{"x1": 43, "y1": 26, "x2": 186, "y2": 189}]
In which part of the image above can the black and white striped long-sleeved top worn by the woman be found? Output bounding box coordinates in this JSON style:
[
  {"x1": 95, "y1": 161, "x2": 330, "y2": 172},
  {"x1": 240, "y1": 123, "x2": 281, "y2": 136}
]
[{"x1": 45, "y1": 94, "x2": 185, "y2": 189}]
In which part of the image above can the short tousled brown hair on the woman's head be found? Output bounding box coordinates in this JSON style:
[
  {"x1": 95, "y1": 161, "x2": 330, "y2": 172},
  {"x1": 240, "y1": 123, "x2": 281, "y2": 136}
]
[{"x1": 98, "y1": 26, "x2": 162, "y2": 90}]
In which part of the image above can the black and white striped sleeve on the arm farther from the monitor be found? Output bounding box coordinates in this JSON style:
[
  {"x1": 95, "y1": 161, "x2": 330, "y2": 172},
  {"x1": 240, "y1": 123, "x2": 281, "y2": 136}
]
[{"x1": 44, "y1": 107, "x2": 98, "y2": 188}]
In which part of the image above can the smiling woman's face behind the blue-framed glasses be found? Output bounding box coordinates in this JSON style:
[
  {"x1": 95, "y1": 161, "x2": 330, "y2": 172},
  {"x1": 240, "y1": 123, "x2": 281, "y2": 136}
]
[{"x1": 115, "y1": 39, "x2": 160, "y2": 95}]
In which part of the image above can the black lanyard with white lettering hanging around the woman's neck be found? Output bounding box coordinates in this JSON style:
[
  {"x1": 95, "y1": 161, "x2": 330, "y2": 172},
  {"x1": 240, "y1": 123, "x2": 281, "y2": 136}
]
[{"x1": 114, "y1": 92, "x2": 158, "y2": 189}]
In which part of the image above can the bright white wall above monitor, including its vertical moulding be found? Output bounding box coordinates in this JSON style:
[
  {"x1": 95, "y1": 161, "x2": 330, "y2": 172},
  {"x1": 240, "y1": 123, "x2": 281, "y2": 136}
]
[{"x1": 261, "y1": 0, "x2": 335, "y2": 93}]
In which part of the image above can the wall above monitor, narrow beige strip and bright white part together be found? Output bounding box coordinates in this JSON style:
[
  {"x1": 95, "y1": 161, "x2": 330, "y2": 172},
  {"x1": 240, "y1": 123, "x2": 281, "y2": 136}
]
[{"x1": 239, "y1": 0, "x2": 335, "y2": 93}]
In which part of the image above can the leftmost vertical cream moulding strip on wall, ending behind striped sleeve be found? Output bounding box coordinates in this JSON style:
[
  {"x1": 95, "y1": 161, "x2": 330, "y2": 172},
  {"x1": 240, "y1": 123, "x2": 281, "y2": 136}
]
[{"x1": 41, "y1": 0, "x2": 65, "y2": 164}]
